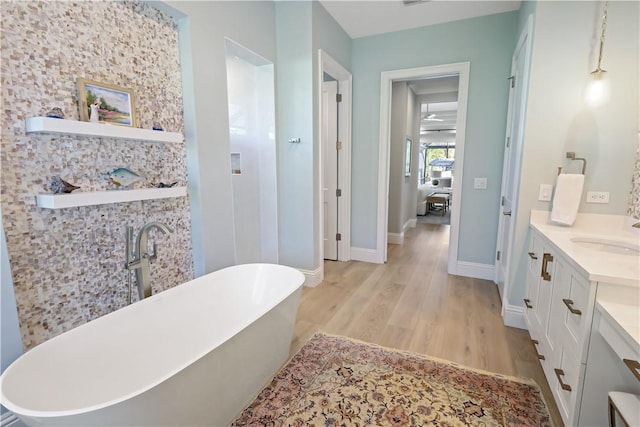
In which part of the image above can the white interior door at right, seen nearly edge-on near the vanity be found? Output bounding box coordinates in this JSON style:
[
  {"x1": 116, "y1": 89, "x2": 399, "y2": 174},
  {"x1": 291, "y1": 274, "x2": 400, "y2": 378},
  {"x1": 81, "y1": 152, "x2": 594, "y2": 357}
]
[{"x1": 495, "y1": 19, "x2": 530, "y2": 301}]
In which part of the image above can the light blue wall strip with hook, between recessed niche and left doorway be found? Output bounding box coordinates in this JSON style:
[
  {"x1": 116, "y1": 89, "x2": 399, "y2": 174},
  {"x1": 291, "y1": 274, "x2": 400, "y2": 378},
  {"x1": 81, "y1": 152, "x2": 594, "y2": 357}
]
[{"x1": 275, "y1": 1, "x2": 318, "y2": 270}]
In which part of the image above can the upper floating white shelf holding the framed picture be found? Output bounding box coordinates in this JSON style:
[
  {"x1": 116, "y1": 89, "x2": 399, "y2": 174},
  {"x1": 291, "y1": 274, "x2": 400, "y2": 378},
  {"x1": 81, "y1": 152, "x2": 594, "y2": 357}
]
[{"x1": 25, "y1": 117, "x2": 183, "y2": 143}]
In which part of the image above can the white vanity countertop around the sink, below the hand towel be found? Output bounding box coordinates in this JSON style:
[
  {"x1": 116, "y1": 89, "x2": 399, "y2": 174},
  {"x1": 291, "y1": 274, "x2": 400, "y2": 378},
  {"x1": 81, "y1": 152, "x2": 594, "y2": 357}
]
[{"x1": 530, "y1": 210, "x2": 640, "y2": 287}]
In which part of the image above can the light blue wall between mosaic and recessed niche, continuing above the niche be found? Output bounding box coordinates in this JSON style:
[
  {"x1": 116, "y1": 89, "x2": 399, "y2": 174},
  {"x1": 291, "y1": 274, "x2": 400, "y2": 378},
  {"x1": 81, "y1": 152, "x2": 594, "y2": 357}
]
[{"x1": 161, "y1": 1, "x2": 276, "y2": 277}]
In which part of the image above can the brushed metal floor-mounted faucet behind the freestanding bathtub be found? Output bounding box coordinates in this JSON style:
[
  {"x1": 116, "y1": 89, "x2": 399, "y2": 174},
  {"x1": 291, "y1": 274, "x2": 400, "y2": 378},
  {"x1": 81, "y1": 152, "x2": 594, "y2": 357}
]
[{"x1": 125, "y1": 222, "x2": 173, "y2": 303}]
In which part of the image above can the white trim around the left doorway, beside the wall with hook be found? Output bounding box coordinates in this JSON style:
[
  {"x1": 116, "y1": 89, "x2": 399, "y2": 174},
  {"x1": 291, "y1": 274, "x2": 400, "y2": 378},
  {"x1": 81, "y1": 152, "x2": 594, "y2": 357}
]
[{"x1": 316, "y1": 49, "x2": 352, "y2": 270}]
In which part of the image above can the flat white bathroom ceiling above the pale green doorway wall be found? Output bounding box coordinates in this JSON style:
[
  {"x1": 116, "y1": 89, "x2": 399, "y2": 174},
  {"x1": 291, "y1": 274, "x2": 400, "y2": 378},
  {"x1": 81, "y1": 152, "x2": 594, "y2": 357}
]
[{"x1": 319, "y1": 0, "x2": 520, "y2": 39}]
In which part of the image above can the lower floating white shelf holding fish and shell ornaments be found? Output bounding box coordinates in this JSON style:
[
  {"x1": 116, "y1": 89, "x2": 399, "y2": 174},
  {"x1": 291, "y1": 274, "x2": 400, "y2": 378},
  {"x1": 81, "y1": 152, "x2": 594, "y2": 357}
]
[{"x1": 36, "y1": 187, "x2": 187, "y2": 209}]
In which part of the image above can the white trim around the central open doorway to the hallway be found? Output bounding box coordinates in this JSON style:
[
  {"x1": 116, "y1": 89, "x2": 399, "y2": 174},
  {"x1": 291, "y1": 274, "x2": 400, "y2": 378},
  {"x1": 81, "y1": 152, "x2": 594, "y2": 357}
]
[{"x1": 376, "y1": 62, "x2": 470, "y2": 274}]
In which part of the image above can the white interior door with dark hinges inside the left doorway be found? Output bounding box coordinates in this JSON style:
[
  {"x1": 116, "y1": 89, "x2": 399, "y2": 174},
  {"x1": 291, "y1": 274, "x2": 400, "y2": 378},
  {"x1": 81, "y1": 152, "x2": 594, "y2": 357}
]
[{"x1": 322, "y1": 81, "x2": 339, "y2": 260}]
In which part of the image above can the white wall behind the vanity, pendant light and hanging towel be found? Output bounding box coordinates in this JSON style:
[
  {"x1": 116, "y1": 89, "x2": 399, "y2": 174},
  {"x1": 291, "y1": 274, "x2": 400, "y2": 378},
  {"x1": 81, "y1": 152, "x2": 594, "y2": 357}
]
[{"x1": 507, "y1": 1, "x2": 640, "y2": 305}]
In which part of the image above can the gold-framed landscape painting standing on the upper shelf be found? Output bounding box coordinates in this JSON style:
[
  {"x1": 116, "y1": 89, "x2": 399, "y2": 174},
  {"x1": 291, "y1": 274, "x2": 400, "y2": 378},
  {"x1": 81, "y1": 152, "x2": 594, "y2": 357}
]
[{"x1": 78, "y1": 78, "x2": 136, "y2": 127}]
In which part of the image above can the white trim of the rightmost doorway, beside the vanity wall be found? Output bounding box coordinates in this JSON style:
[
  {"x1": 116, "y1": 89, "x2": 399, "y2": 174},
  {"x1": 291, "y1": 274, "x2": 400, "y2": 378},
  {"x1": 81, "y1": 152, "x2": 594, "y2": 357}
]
[{"x1": 494, "y1": 15, "x2": 533, "y2": 320}]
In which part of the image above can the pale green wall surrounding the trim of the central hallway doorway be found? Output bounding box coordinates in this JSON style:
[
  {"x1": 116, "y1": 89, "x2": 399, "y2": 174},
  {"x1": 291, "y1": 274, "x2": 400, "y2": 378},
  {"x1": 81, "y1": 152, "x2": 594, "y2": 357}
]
[{"x1": 352, "y1": 12, "x2": 518, "y2": 265}]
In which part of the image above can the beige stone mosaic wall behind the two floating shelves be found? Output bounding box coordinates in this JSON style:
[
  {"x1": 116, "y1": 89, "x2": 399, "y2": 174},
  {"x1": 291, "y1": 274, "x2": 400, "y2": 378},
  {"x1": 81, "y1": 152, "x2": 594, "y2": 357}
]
[{"x1": 0, "y1": 1, "x2": 193, "y2": 348}]
